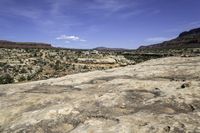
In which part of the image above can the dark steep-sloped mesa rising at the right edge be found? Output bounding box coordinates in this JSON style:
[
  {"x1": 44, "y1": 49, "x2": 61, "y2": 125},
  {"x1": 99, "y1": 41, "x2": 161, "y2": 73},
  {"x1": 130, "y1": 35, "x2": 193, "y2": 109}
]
[{"x1": 138, "y1": 28, "x2": 200, "y2": 50}]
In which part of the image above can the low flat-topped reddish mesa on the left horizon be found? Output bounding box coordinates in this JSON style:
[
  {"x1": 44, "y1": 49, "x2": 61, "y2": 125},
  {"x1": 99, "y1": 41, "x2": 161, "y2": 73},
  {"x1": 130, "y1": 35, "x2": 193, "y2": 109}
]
[{"x1": 0, "y1": 40, "x2": 53, "y2": 48}]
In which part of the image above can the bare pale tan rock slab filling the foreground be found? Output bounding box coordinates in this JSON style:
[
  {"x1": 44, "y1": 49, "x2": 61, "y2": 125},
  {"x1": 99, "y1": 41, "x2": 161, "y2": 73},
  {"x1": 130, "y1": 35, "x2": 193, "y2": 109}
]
[{"x1": 0, "y1": 57, "x2": 200, "y2": 133}]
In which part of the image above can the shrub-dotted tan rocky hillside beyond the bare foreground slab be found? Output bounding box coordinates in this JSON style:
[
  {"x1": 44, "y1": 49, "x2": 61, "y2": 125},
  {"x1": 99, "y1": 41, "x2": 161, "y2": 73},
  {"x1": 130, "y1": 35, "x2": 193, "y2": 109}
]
[{"x1": 0, "y1": 48, "x2": 135, "y2": 84}]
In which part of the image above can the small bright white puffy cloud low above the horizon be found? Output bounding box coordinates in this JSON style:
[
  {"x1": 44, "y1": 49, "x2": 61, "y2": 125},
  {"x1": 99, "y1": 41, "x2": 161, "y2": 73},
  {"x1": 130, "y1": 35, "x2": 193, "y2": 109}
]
[{"x1": 56, "y1": 35, "x2": 86, "y2": 43}]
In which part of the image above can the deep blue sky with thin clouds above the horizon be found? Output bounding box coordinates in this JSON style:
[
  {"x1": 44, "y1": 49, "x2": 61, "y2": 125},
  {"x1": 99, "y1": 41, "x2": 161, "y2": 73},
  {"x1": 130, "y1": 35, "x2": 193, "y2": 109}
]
[{"x1": 0, "y1": 0, "x2": 200, "y2": 48}]
